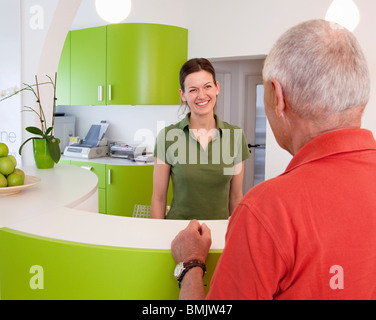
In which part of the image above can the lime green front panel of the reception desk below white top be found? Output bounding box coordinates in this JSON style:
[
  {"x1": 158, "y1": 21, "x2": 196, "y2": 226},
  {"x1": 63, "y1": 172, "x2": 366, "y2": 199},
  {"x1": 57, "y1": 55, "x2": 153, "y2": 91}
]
[{"x1": 0, "y1": 228, "x2": 221, "y2": 300}]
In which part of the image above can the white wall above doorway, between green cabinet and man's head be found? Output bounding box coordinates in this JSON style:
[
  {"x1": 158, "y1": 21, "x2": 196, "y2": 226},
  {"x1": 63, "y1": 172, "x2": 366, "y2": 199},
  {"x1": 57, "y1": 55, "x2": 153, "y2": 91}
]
[{"x1": 185, "y1": 0, "x2": 332, "y2": 57}]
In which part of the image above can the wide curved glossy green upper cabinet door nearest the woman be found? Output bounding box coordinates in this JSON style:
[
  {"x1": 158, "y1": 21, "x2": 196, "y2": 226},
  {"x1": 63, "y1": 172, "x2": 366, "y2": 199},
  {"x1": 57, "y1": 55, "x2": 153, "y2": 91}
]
[{"x1": 107, "y1": 23, "x2": 188, "y2": 105}]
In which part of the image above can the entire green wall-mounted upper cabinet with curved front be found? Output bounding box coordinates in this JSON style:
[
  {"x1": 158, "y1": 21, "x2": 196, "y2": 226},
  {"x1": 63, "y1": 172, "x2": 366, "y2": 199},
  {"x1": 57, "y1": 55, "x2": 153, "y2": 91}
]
[{"x1": 57, "y1": 23, "x2": 188, "y2": 105}]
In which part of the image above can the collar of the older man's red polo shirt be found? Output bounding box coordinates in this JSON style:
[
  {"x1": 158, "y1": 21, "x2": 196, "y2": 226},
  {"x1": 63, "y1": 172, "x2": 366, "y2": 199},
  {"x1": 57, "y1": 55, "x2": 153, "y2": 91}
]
[{"x1": 285, "y1": 128, "x2": 376, "y2": 173}]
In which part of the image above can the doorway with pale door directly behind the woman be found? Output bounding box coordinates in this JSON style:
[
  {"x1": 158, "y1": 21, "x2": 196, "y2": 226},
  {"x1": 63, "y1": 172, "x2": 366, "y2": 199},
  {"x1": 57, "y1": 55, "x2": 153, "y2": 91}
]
[{"x1": 210, "y1": 58, "x2": 266, "y2": 194}]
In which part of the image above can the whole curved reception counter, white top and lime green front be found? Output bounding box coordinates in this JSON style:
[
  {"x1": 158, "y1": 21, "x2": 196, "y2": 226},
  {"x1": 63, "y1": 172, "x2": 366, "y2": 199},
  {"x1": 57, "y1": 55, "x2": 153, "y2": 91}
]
[{"x1": 0, "y1": 164, "x2": 227, "y2": 300}]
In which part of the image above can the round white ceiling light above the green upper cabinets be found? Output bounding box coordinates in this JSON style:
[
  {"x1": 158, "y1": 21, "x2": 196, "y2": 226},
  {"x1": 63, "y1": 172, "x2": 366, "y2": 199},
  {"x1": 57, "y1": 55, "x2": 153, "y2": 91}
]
[{"x1": 95, "y1": 0, "x2": 132, "y2": 23}]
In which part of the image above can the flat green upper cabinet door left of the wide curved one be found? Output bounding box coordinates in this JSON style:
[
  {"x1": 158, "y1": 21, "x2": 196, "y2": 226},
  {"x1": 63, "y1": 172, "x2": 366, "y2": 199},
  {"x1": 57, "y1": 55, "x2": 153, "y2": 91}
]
[{"x1": 71, "y1": 27, "x2": 106, "y2": 105}]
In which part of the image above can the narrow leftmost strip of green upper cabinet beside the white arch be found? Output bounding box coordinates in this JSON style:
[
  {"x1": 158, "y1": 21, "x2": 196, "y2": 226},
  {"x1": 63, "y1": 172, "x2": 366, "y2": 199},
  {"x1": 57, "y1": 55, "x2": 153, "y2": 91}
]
[{"x1": 56, "y1": 32, "x2": 71, "y2": 106}]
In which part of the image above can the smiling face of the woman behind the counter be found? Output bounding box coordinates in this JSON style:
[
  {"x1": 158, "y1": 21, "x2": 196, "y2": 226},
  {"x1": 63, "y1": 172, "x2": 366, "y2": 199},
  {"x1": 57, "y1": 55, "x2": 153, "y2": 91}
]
[{"x1": 179, "y1": 70, "x2": 219, "y2": 116}]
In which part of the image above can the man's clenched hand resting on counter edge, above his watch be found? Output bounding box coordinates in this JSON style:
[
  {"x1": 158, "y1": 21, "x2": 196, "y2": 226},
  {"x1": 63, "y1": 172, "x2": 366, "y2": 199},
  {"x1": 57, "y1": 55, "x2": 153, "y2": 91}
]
[{"x1": 171, "y1": 220, "x2": 212, "y2": 263}]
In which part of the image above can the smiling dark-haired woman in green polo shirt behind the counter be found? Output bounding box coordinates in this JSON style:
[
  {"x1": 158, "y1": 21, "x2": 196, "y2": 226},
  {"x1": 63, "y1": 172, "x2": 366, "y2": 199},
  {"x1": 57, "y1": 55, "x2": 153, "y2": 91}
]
[{"x1": 151, "y1": 59, "x2": 250, "y2": 220}]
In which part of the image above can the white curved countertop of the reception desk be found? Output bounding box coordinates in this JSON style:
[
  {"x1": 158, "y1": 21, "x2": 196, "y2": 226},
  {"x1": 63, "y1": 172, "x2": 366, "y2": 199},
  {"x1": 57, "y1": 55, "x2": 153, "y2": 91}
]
[{"x1": 0, "y1": 165, "x2": 228, "y2": 250}]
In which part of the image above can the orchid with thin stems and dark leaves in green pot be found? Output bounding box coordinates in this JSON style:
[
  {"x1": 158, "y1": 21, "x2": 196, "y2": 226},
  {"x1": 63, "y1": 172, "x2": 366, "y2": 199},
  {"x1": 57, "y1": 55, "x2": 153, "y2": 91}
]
[{"x1": 0, "y1": 73, "x2": 61, "y2": 163}]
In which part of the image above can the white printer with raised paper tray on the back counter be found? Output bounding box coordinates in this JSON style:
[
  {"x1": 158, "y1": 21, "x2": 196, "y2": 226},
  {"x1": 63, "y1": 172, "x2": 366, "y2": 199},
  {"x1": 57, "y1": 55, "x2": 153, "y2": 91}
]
[{"x1": 64, "y1": 122, "x2": 110, "y2": 159}]
